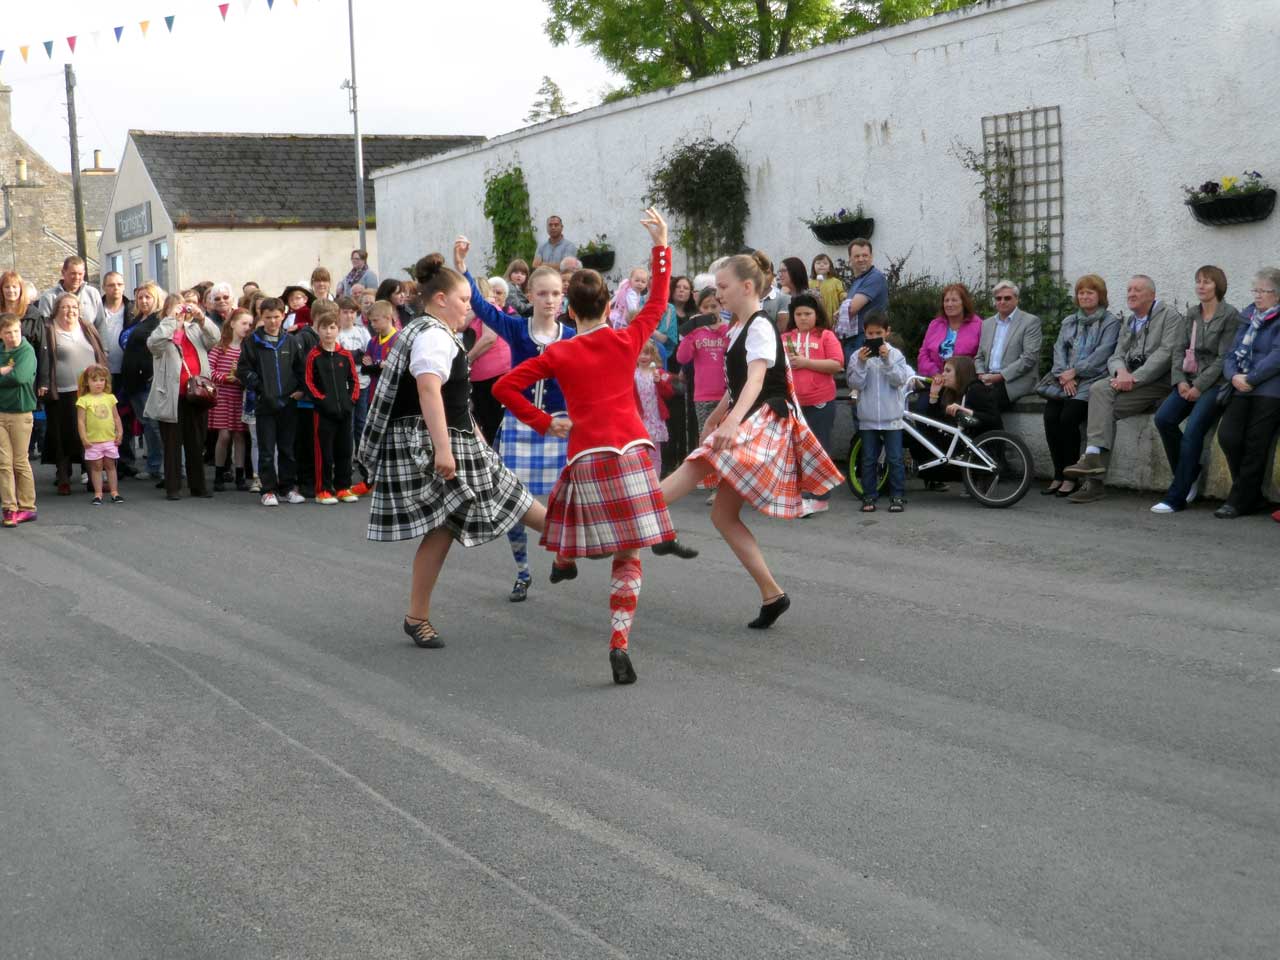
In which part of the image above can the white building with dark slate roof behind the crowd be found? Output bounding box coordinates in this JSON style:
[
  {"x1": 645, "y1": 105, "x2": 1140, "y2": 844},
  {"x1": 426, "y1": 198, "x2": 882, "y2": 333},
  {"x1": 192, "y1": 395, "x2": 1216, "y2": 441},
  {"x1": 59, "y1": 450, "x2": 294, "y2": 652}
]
[{"x1": 99, "y1": 131, "x2": 483, "y2": 292}]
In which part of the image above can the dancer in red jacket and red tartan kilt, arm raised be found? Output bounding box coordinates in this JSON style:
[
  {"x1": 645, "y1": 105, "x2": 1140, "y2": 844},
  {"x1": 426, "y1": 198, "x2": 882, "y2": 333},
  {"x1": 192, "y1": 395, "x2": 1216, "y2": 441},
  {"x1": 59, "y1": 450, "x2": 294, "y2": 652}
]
[{"x1": 493, "y1": 209, "x2": 694, "y2": 684}]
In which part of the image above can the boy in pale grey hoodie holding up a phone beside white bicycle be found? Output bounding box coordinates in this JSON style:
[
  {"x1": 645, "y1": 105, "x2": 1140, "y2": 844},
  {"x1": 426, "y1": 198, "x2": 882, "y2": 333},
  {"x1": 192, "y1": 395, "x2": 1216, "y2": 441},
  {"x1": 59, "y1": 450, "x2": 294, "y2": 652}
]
[{"x1": 845, "y1": 310, "x2": 915, "y2": 513}]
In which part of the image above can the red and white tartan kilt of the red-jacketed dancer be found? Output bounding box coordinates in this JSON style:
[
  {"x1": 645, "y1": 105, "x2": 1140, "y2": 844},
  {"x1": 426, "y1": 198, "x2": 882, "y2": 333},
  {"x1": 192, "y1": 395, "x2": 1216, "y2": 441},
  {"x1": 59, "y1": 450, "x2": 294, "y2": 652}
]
[{"x1": 540, "y1": 445, "x2": 676, "y2": 557}]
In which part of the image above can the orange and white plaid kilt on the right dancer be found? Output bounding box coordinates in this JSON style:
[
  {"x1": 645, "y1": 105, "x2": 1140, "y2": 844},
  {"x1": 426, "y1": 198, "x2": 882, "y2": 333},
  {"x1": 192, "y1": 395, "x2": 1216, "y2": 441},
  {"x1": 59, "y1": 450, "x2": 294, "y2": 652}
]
[{"x1": 687, "y1": 404, "x2": 845, "y2": 520}]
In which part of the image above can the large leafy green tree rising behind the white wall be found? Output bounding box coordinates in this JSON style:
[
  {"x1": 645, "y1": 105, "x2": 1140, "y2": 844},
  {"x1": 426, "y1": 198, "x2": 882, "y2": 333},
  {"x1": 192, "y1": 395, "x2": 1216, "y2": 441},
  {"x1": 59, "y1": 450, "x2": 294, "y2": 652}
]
[{"x1": 547, "y1": 0, "x2": 975, "y2": 99}]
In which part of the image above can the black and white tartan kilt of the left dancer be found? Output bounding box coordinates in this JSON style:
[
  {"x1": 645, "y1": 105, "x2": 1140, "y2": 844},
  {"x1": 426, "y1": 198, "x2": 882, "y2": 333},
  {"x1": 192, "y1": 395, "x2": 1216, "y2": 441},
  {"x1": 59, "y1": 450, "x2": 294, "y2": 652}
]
[{"x1": 369, "y1": 417, "x2": 534, "y2": 547}]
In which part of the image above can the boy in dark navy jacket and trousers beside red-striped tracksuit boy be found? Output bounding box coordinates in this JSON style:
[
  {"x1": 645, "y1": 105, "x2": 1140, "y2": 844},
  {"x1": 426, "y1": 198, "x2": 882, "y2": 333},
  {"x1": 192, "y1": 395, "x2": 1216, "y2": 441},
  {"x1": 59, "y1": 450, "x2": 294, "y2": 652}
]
[{"x1": 236, "y1": 298, "x2": 302, "y2": 507}]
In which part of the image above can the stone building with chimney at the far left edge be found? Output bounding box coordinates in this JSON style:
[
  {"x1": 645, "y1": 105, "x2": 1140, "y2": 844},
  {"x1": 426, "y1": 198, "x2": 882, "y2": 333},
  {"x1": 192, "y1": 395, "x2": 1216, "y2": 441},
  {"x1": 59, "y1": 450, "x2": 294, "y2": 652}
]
[{"x1": 0, "y1": 83, "x2": 115, "y2": 289}]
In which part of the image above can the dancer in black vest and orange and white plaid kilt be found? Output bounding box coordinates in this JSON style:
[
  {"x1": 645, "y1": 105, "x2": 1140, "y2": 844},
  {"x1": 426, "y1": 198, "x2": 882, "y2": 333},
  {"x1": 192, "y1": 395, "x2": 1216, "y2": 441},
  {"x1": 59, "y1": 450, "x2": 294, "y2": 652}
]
[{"x1": 662, "y1": 256, "x2": 844, "y2": 630}]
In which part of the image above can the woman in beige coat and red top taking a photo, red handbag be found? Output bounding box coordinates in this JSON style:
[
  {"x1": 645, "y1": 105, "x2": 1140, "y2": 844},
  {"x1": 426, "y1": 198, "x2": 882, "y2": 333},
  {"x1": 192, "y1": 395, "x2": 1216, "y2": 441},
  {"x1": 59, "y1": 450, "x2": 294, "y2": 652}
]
[{"x1": 143, "y1": 297, "x2": 221, "y2": 500}]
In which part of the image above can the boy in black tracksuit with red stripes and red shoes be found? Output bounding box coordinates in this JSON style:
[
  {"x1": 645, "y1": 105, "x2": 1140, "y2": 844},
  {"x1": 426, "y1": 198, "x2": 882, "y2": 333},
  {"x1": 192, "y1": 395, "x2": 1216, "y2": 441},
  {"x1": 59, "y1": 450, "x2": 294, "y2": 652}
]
[{"x1": 305, "y1": 314, "x2": 360, "y2": 503}]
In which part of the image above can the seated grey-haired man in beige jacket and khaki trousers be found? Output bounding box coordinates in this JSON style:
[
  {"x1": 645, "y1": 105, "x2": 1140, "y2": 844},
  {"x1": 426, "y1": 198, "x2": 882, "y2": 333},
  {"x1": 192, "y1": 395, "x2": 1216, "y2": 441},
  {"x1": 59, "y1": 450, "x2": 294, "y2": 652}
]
[{"x1": 1062, "y1": 274, "x2": 1187, "y2": 503}]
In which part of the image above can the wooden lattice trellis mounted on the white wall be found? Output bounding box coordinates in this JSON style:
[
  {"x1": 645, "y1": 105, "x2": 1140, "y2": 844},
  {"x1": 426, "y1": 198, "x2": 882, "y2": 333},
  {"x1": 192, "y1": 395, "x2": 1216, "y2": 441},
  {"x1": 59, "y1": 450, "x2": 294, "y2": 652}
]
[{"x1": 982, "y1": 106, "x2": 1062, "y2": 283}]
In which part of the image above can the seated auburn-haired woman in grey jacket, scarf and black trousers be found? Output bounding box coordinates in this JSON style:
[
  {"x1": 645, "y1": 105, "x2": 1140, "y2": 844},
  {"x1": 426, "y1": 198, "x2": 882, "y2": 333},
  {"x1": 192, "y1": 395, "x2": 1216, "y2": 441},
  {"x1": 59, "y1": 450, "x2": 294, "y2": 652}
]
[{"x1": 1036, "y1": 274, "x2": 1120, "y2": 497}]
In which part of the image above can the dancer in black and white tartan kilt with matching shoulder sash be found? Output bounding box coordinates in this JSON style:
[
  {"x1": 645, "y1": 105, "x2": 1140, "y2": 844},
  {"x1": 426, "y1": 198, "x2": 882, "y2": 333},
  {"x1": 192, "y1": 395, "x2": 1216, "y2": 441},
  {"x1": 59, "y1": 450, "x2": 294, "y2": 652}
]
[{"x1": 356, "y1": 253, "x2": 550, "y2": 648}]
